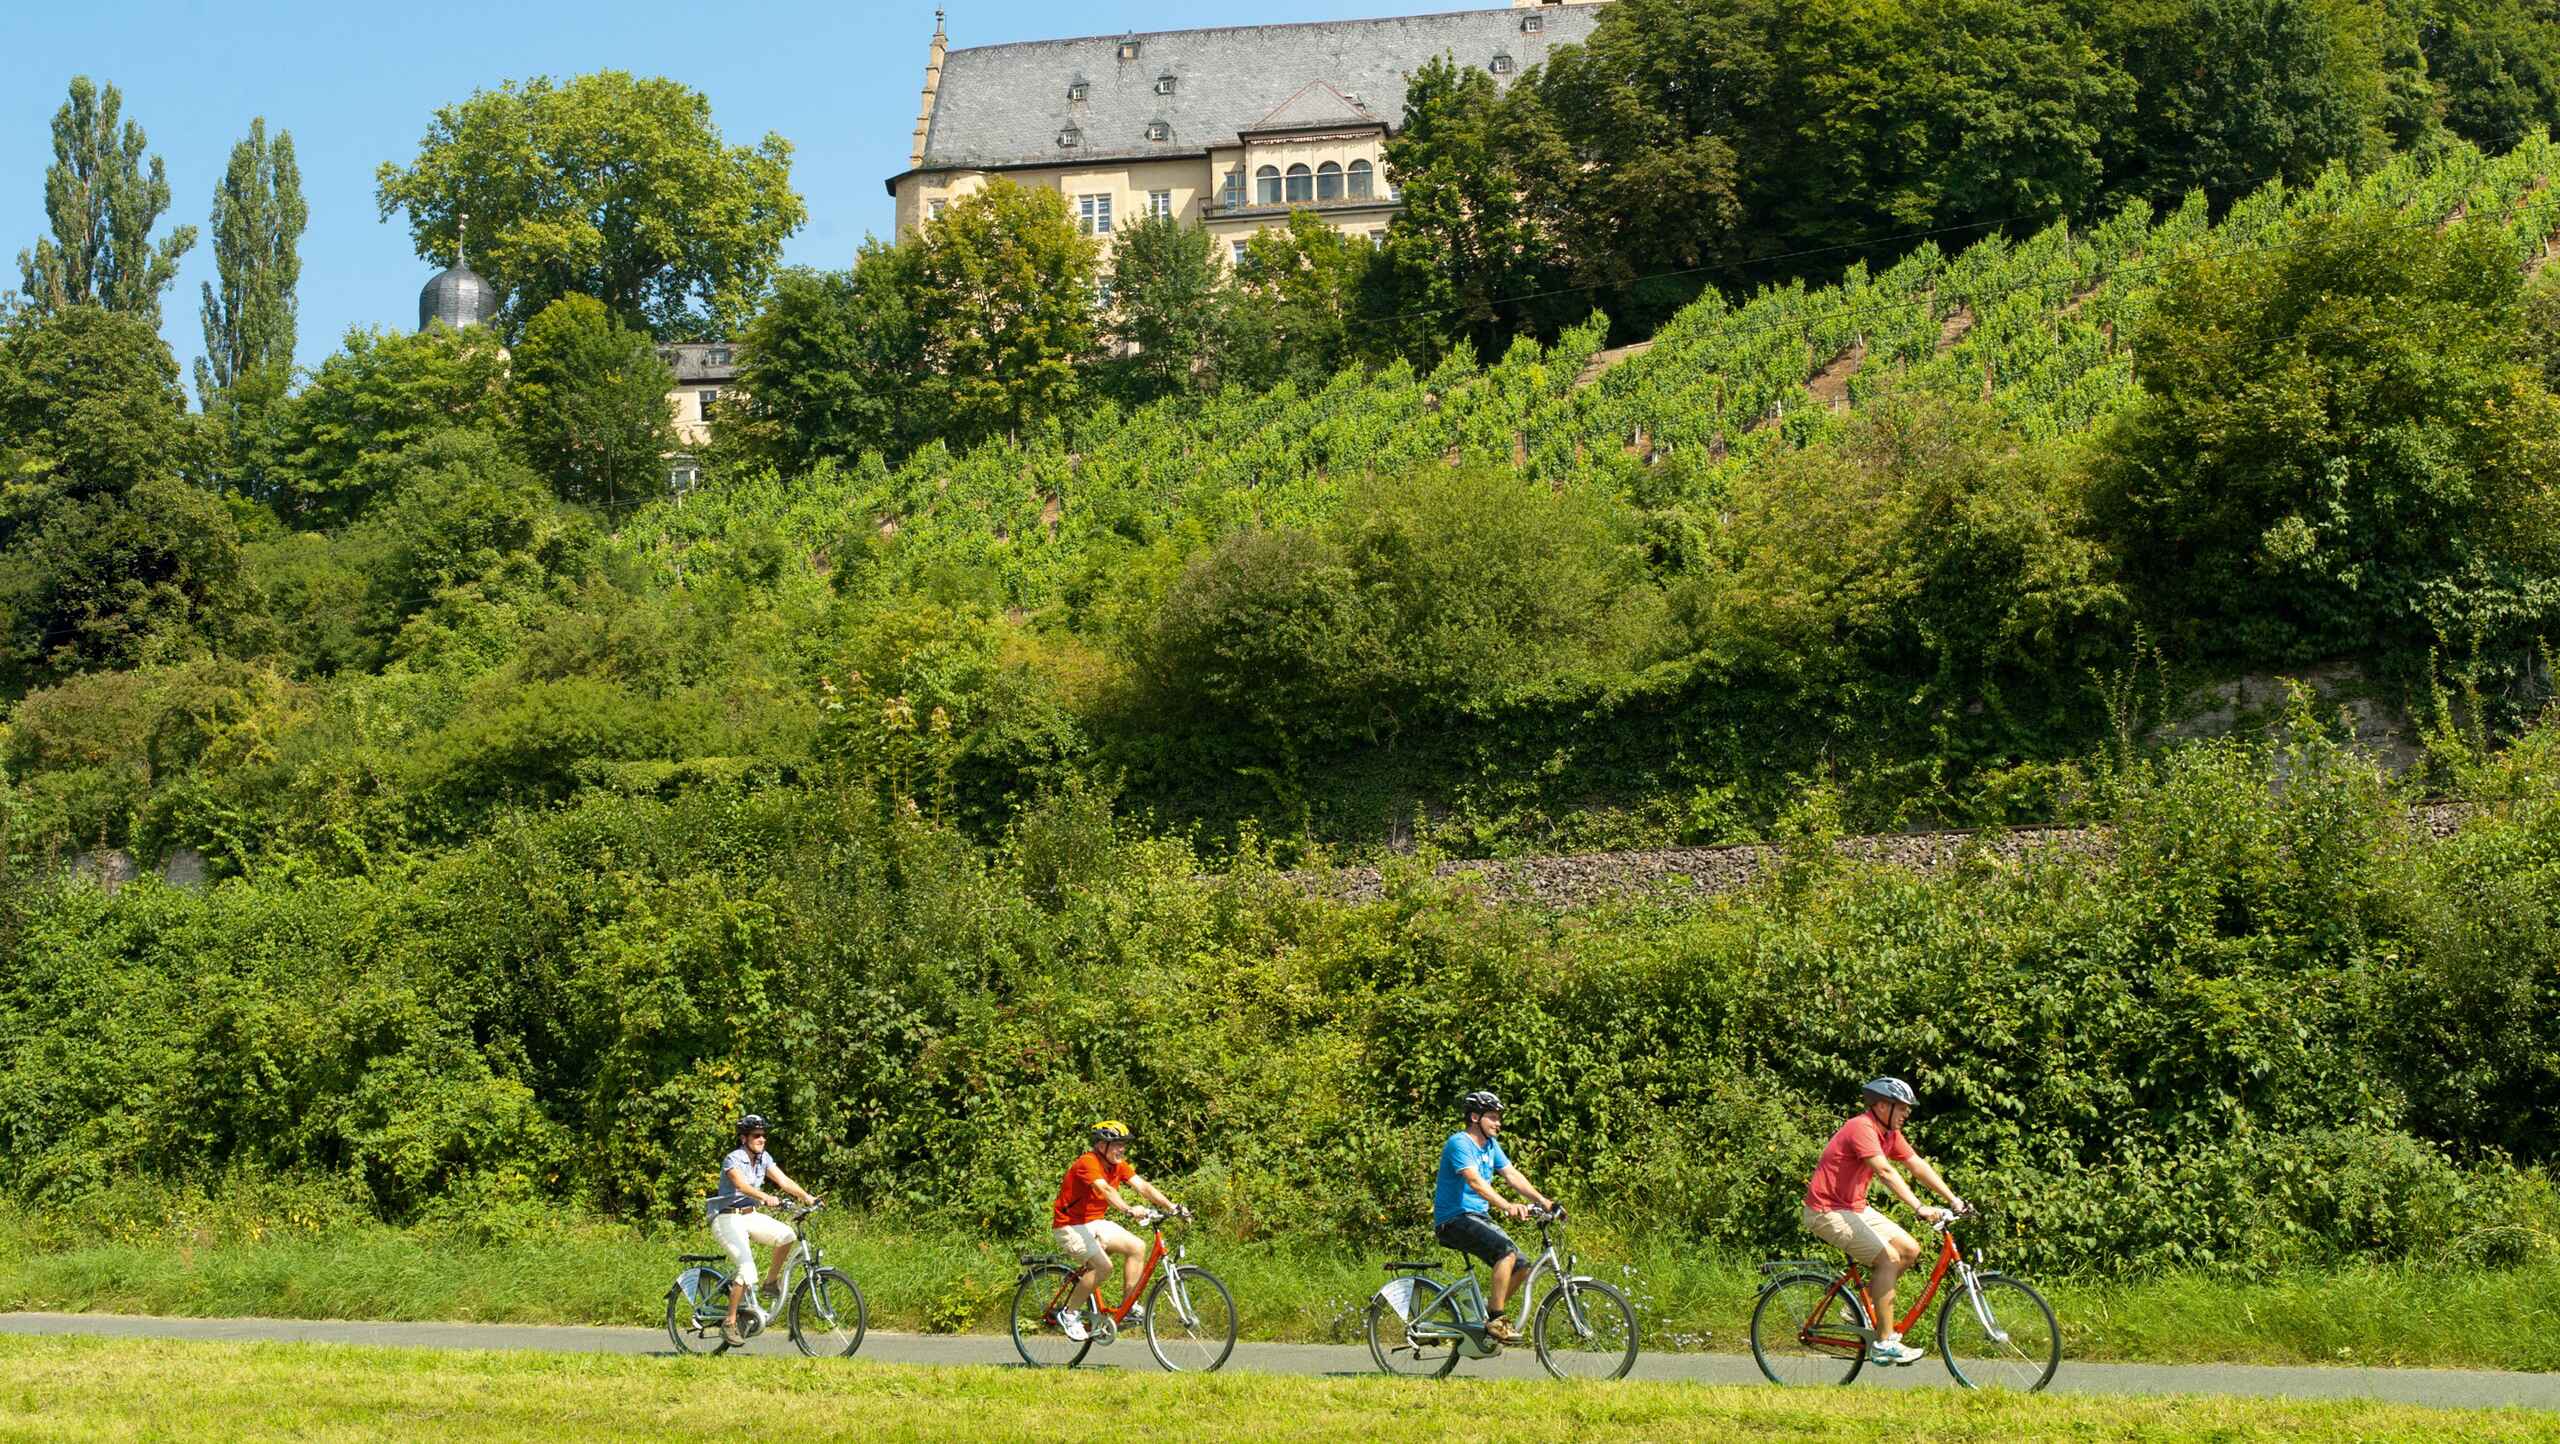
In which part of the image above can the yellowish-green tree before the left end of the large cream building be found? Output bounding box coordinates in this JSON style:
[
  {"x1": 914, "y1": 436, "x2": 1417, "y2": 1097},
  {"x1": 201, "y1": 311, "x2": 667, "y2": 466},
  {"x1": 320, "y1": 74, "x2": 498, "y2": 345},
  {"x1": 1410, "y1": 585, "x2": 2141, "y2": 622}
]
[{"x1": 904, "y1": 177, "x2": 1101, "y2": 440}]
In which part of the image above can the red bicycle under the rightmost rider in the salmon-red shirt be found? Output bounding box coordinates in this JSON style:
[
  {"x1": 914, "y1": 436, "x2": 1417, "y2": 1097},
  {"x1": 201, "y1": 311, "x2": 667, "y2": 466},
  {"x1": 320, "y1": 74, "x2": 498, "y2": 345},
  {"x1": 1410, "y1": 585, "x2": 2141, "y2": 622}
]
[{"x1": 1751, "y1": 1219, "x2": 2063, "y2": 1393}]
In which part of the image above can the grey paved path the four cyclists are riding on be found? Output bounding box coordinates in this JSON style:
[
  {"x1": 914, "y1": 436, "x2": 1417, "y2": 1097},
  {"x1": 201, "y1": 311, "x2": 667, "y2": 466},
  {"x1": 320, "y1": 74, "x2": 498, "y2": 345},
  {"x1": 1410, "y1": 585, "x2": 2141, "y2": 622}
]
[{"x1": 0, "y1": 1313, "x2": 2560, "y2": 1411}]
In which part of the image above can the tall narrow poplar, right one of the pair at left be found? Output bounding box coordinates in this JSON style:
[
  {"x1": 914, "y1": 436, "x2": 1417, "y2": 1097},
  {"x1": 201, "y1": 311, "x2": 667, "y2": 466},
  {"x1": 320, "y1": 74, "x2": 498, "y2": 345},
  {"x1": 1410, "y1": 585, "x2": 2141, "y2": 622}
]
[{"x1": 195, "y1": 115, "x2": 310, "y2": 412}]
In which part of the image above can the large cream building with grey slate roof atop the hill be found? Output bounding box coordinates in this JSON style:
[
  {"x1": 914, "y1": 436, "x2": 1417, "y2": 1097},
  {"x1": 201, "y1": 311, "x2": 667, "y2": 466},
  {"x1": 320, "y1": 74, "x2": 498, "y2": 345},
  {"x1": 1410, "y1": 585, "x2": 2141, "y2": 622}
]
[{"x1": 888, "y1": 0, "x2": 1605, "y2": 259}]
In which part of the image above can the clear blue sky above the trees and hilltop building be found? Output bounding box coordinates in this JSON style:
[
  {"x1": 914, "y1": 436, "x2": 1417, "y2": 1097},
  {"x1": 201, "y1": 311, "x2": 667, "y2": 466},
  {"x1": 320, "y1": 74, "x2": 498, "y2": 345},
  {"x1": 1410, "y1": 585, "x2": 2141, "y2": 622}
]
[{"x1": 0, "y1": 0, "x2": 1423, "y2": 391}]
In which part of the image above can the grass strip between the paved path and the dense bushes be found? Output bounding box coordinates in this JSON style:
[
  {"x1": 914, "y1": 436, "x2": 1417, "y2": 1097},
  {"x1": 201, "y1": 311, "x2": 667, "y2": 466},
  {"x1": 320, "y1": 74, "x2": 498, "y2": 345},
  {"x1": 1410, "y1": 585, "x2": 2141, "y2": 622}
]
[{"x1": 0, "y1": 1214, "x2": 2560, "y2": 1370}]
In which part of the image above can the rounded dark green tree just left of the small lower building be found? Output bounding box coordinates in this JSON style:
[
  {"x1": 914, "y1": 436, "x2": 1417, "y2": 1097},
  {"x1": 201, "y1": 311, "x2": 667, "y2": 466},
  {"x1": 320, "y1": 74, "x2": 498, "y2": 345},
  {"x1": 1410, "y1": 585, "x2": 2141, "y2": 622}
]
[{"x1": 507, "y1": 297, "x2": 676, "y2": 509}]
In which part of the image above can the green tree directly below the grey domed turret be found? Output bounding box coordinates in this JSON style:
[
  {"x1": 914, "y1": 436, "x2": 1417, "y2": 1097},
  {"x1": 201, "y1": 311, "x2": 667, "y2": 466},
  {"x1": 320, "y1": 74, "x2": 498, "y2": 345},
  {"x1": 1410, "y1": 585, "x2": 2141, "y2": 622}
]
[{"x1": 261, "y1": 325, "x2": 507, "y2": 525}]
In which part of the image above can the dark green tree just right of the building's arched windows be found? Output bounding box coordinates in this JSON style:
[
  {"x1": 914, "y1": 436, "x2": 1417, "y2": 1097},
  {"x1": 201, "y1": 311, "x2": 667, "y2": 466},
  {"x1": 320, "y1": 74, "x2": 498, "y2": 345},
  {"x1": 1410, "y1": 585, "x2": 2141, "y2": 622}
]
[{"x1": 1372, "y1": 56, "x2": 1556, "y2": 353}]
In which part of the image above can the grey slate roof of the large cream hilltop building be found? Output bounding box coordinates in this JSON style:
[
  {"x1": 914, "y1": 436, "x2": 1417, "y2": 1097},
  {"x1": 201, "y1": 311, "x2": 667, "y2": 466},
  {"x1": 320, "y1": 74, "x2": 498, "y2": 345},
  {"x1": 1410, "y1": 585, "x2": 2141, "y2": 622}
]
[{"x1": 891, "y1": 5, "x2": 1603, "y2": 189}]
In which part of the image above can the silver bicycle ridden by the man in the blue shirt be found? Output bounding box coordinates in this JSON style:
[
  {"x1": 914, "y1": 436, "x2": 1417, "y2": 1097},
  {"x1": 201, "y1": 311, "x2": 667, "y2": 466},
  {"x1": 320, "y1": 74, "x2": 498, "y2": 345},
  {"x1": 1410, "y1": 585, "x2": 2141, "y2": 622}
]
[{"x1": 1367, "y1": 1208, "x2": 1636, "y2": 1380}]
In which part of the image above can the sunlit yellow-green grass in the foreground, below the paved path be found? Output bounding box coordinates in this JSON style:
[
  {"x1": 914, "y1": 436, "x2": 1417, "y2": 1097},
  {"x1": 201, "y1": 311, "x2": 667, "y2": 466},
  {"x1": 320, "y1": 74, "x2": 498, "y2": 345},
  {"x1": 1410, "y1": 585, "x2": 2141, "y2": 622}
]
[{"x1": 0, "y1": 1336, "x2": 2550, "y2": 1444}]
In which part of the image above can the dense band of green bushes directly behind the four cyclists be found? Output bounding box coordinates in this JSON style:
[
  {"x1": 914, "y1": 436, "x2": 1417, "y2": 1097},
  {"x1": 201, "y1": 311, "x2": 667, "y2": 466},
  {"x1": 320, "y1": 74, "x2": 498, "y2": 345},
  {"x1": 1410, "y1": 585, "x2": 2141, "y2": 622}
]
[{"x1": 0, "y1": 709, "x2": 2560, "y2": 1267}]
